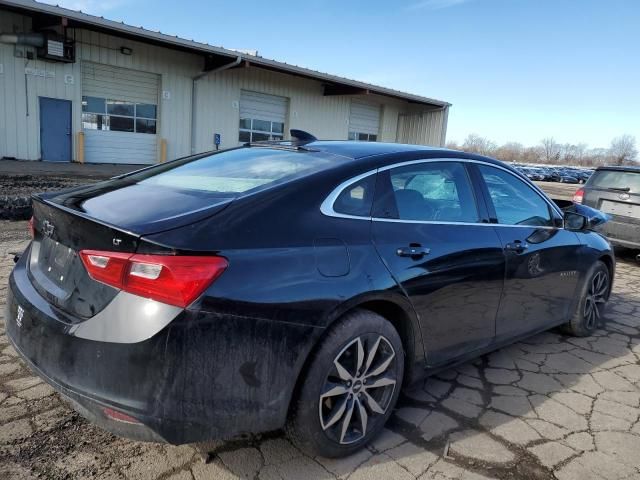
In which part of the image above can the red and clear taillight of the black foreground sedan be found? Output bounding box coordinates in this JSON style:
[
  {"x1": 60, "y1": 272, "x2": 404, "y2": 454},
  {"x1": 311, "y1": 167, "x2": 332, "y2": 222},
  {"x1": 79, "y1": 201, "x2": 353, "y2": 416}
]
[{"x1": 80, "y1": 250, "x2": 228, "y2": 308}]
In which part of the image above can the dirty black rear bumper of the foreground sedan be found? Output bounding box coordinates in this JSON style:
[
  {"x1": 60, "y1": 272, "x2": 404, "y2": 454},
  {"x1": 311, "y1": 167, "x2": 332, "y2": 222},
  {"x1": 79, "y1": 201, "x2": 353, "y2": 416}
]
[{"x1": 5, "y1": 255, "x2": 321, "y2": 444}]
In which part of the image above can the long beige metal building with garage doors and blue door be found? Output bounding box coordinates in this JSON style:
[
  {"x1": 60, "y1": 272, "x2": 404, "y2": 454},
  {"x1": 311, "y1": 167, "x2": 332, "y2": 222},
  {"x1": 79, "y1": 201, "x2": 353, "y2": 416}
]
[{"x1": 0, "y1": 0, "x2": 450, "y2": 164}]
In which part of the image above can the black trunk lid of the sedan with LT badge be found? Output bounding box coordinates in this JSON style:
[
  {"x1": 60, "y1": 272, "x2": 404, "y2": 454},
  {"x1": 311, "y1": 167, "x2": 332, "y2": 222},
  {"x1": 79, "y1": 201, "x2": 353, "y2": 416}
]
[{"x1": 28, "y1": 179, "x2": 231, "y2": 323}]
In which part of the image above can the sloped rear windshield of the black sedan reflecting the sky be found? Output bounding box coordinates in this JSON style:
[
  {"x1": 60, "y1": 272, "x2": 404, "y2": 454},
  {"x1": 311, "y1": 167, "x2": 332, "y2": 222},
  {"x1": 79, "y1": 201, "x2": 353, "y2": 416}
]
[{"x1": 126, "y1": 147, "x2": 345, "y2": 197}]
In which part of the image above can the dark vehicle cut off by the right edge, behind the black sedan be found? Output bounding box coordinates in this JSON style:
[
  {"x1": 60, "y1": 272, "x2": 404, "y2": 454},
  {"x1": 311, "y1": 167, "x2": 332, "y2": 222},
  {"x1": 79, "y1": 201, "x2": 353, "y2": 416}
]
[{"x1": 573, "y1": 166, "x2": 640, "y2": 249}]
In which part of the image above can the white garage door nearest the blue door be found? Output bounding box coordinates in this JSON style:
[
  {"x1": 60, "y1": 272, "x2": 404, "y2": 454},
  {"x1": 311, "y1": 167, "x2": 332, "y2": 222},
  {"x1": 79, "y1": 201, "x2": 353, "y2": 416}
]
[{"x1": 82, "y1": 62, "x2": 160, "y2": 164}]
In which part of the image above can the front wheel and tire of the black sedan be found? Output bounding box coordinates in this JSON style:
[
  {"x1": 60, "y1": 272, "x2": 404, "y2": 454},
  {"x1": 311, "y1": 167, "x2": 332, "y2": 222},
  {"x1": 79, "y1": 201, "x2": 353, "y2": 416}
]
[{"x1": 564, "y1": 260, "x2": 611, "y2": 337}]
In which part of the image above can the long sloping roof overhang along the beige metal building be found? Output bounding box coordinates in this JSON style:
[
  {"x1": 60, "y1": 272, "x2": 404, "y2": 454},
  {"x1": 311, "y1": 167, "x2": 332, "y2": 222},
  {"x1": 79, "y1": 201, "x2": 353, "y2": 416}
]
[{"x1": 0, "y1": 0, "x2": 451, "y2": 108}]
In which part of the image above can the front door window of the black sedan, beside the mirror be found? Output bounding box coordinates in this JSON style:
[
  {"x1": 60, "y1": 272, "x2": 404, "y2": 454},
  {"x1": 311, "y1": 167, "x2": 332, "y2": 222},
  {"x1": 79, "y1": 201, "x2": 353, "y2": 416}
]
[{"x1": 478, "y1": 165, "x2": 553, "y2": 226}]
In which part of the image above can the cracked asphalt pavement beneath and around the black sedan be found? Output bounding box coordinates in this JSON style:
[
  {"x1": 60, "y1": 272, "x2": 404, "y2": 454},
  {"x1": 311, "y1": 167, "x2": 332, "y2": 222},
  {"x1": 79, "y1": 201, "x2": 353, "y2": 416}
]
[{"x1": 0, "y1": 218, "x2": 640, "y2": 480}]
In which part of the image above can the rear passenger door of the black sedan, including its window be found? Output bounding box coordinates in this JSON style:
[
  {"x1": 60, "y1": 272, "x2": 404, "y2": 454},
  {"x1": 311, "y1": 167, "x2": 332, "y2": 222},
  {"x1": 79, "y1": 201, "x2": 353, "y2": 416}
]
[{"x1": 372, "y1": 160, "x2": 504, "y2": 365}]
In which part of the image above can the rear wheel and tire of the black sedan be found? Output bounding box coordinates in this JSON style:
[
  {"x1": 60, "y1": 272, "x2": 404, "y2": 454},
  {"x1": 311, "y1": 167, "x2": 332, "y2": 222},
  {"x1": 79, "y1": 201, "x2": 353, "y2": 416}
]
[{"x1": 285, "y1": 310, "x2": 404, "y2": 458}]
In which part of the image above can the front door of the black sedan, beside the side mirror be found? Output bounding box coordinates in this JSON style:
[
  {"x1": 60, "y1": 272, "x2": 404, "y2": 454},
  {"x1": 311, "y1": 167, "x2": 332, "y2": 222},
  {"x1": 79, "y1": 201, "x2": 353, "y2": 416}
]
[{"x1": 473, "y1": 164, "x2": 581, "y2": 341}]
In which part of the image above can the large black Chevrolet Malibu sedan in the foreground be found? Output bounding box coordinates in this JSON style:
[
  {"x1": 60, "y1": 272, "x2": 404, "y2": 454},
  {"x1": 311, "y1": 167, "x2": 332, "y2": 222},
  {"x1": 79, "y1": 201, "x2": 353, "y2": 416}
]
[{"x1": 6, "y1": 133, "x2": 615, "y2": 456}]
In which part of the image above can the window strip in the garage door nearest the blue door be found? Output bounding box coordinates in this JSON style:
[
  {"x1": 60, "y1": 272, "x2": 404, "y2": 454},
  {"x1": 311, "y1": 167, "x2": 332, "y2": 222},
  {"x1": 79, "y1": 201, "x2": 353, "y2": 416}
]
[{"x1": 82, "y1": 97, "x2": 158, "y2": 134}]
